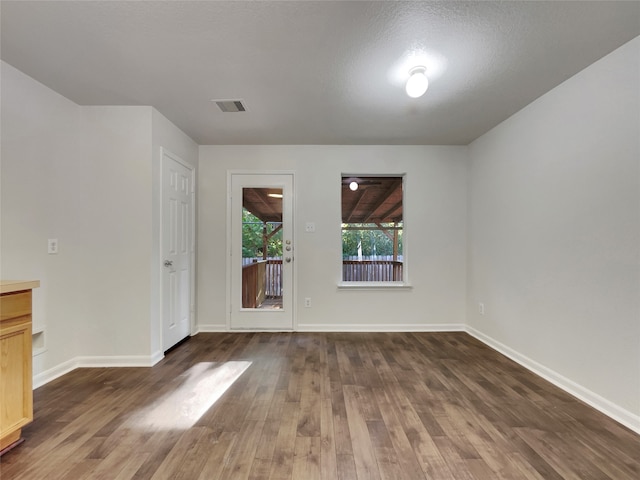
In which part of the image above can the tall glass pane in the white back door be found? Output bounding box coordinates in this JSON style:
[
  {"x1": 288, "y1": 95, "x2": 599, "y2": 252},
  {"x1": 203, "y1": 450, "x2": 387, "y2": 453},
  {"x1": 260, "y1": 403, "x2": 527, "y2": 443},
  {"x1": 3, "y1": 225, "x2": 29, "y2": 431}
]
[{"x1": 242, "y1": 187, "x2": 283, "y2": 309}]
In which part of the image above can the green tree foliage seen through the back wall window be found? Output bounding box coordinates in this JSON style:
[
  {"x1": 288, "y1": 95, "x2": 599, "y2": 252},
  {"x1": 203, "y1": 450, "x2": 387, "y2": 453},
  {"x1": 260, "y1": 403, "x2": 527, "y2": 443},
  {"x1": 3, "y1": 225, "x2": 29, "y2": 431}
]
[{"x1": 342, "y1": 223, "x2": 402, "y2": 258}]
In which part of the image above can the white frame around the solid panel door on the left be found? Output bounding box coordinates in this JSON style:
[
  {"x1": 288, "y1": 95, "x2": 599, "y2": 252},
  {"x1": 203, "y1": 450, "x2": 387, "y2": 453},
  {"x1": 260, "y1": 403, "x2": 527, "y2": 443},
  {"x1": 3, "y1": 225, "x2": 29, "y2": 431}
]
[{"x1": 156, "y1": 147, "x2": 197, "y2": 353}]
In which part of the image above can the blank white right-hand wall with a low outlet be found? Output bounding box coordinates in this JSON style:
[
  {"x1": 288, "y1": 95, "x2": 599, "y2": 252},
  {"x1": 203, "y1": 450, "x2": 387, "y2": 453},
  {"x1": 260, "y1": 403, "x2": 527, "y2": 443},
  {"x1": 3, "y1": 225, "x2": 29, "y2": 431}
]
[{"x1": 467, "y1": 38, "x2": 640, "y2": 430}]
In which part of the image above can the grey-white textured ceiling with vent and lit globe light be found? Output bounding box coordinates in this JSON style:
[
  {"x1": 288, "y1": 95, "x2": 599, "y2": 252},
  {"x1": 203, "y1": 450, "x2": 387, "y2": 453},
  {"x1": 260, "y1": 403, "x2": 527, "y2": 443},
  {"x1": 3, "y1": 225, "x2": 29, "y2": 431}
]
[{"x1": 0, "y1": 0, "x2": 640, "y2": 145}]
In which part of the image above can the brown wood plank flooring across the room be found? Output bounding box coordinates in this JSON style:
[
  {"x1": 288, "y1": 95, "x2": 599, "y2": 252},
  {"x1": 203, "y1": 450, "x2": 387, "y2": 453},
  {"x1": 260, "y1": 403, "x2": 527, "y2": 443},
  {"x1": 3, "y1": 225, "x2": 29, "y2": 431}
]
[{"x1": 0, "y1": 333, "x2": 640, "y2": 480}]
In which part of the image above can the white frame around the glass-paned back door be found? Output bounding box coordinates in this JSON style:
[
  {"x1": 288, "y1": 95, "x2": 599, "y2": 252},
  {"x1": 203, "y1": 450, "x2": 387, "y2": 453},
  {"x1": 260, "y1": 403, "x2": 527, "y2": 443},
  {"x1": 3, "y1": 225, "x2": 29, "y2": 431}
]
[{"x1": 225, "y1": 170, "x2": 298, "y2": 332}]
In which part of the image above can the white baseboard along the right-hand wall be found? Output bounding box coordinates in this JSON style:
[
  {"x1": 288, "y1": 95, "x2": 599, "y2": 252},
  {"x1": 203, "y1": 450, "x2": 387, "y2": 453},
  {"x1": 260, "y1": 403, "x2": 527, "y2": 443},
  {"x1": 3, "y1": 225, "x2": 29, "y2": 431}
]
[{"x1": 466, "y1": 326, "x2": 640, "y2": 434}]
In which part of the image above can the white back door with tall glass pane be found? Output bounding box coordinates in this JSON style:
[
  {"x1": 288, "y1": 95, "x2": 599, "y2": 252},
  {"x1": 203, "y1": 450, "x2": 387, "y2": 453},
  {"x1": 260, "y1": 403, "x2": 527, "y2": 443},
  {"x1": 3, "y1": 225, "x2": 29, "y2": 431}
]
[{"x1": 228, "y1": 173, "x2": 295, "y2": 330}]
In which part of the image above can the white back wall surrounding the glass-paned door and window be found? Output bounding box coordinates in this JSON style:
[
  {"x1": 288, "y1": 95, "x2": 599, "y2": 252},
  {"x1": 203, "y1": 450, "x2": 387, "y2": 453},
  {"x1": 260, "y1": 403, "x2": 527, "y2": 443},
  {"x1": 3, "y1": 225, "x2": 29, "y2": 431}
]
[{"x1": 198, "y1": 146, "x2": 468, "y2": 330}]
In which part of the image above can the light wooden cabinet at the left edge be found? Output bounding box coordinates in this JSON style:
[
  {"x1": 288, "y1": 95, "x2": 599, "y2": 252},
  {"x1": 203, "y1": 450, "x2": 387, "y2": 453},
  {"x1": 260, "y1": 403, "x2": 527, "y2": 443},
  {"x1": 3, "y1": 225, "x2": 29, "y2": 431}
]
[{"x1": 0, "y1": 281, "x2": 39, "y2": 452}]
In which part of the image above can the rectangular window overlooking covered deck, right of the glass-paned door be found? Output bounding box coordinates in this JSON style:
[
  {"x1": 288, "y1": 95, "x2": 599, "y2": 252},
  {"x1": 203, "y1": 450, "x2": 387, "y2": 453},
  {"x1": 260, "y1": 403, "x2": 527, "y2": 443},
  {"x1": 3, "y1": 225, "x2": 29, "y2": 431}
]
[{"x1": 342, "y1": 175, "x2": 404, "y2": 282}]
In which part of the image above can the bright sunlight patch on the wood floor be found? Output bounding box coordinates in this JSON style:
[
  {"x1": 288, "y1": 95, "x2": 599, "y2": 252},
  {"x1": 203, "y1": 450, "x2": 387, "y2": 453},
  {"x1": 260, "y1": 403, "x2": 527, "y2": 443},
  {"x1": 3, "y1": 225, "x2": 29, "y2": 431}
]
[{"x1": 134, "y1": 361, "x2": 251, "y2": 430}]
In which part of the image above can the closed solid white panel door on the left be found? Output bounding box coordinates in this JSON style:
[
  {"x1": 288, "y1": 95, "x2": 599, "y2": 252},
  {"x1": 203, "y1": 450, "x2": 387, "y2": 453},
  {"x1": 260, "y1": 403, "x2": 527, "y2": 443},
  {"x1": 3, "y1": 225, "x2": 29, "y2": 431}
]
[{"x1": 161, "y1": 150, "x2": 194, "y2": 351}]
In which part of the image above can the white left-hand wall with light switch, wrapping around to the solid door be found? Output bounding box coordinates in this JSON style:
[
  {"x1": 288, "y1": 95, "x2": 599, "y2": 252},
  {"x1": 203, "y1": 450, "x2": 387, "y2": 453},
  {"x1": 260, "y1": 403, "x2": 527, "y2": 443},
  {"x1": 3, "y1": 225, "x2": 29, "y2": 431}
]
[{"x1": 0, "y1": 62, "x2": 198, "y2": 385}]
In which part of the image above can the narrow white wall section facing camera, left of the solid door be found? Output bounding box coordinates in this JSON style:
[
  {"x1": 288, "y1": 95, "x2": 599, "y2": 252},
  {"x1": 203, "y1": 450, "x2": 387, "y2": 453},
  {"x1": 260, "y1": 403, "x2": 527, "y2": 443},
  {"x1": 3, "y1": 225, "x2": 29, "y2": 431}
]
[{"x1": 75, "y1": 106, "x2": 152, "y2": 357}]
